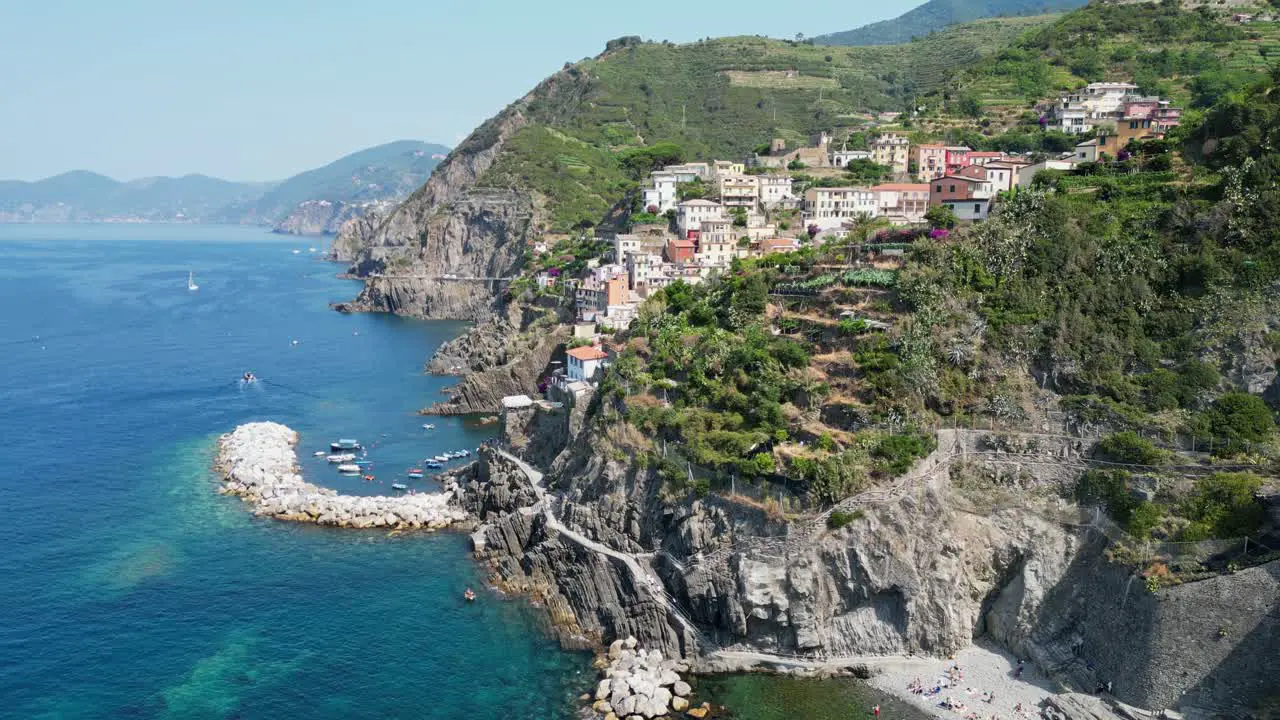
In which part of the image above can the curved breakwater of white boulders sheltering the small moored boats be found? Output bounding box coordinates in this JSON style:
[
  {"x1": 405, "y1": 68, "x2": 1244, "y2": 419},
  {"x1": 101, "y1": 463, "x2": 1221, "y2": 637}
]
[{"x1": 215, "y1": 423, "x2": 467, "y2": 529}]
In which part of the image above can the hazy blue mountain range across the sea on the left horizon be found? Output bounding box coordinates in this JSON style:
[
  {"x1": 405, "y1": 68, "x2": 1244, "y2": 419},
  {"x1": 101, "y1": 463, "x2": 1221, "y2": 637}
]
[{"x1": 0, "y1": 140, "x2": 449, "y2": 234}]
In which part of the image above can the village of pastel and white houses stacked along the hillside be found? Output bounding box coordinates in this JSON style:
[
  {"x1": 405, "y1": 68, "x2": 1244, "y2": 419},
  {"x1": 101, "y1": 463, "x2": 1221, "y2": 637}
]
[{"x1": 532, "y1": 82, "x2": 1181, "y2": 389}]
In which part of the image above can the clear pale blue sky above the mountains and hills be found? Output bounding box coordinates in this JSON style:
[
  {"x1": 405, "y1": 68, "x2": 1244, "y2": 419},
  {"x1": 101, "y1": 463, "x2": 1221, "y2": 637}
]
[{"x1": 0, "y1": 0, "x2": 922, "y2": 181}]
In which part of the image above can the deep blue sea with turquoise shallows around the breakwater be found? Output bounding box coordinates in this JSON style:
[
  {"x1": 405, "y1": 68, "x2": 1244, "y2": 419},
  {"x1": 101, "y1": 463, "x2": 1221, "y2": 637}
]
[{"x1": 0, "y1": 225, "x2": 591, "y2": 720}]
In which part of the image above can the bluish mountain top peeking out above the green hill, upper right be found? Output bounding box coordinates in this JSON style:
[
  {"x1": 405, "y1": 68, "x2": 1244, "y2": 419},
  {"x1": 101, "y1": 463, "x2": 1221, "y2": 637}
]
[{"x1": 813, "y1": 0, "x2": 1087, "y2": 45}]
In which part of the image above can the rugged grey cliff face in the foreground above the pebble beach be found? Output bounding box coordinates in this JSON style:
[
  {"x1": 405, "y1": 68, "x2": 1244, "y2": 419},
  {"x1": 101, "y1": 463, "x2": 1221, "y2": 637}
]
[{"x1": 463, "y1": 409, "x2": 1280, "y2": 711}]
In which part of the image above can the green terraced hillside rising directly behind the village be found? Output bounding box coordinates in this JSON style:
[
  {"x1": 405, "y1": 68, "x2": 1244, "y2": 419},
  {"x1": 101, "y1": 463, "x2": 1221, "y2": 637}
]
[{"x1": 481, "y1": 17, "x2": 1051, "y2": 231}]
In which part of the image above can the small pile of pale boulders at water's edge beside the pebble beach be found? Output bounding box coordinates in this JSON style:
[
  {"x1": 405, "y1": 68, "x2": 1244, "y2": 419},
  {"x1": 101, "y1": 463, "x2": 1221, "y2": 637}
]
[{"x1": 591, "y1": 638, "x2": 692, "y2": 720}]
